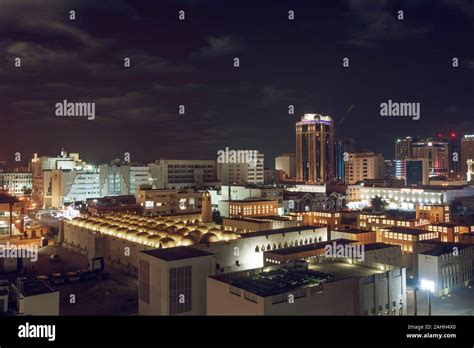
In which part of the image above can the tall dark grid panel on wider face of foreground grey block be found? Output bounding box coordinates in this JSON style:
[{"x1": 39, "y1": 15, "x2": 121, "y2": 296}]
[{"x1": 169, "y1": 266, "x2": 192, "y2": 315}]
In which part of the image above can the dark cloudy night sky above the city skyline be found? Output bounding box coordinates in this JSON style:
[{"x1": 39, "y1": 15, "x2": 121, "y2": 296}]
[{"x1": 0, "y1": 0, "x2": 474, "y2": 167}]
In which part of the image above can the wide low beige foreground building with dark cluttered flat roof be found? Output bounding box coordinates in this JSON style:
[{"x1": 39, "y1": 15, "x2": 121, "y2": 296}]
[{"x1": 207, "y1": 262, "x2": 407, "y2": 315}]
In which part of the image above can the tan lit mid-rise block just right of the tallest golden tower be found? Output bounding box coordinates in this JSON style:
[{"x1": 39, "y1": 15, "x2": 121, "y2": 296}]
[{"x1": 345, "y1": 152, "x2": 385, "y2": 185}]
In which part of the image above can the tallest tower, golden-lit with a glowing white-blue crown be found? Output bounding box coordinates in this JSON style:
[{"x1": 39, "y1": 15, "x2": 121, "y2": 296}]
[{"x1": 296, "y1": 114, "x2": 334, "y2": 183}]
